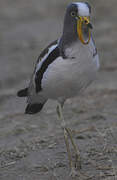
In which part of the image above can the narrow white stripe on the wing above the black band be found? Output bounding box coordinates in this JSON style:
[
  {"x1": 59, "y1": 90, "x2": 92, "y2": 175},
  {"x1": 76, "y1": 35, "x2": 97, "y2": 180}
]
[{"x1": 35, "y1": 44, "x2": 58, "y2": 73}]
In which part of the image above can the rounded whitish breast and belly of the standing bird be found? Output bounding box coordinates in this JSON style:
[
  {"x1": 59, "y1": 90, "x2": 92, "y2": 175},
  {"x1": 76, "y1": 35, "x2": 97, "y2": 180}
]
[{"x1": 42, "y1": 39, "x2": 97, "y2": 99}]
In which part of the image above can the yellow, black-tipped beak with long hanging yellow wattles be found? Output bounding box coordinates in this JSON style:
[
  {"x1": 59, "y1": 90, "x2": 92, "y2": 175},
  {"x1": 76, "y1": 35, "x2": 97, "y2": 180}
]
[{"x1": 77, "y1": 16, "x2": 93, "y2": 45}]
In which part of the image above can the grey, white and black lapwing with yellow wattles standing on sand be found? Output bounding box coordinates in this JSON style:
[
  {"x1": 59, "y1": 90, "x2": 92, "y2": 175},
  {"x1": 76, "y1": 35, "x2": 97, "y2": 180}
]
[{"x1": 17, "y1": 2, "x2": 100, "y2": 175}]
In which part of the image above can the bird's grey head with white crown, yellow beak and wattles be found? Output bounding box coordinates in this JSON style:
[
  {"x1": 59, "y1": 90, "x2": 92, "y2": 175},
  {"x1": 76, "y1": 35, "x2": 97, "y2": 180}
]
[{"x1": 64, "y1": 2, "x2": 92, "y2": 44}]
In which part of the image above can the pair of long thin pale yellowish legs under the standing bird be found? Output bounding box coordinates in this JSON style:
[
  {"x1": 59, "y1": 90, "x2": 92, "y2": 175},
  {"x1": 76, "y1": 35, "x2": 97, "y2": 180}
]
[{"x1": 57, "y1": 104, "x2": 81, "y2": 176}]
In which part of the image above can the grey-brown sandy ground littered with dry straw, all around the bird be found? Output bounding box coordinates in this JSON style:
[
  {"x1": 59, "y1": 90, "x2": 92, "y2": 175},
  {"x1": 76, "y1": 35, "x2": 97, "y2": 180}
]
[{"x1": 0, "y1": 0, "x2": 117, "y2": 180}]
